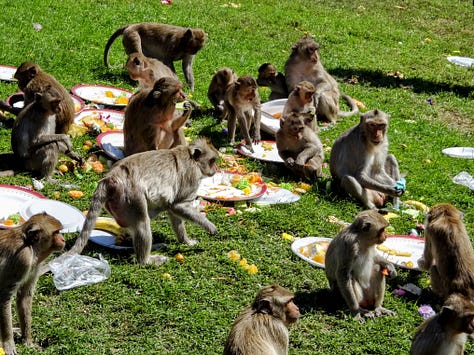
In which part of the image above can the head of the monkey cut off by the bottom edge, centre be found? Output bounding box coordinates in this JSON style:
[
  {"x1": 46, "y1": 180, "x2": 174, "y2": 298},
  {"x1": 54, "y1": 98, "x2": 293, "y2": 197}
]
[{"x1": 252, "y1": 285, "x2": 301, "y2": 326}]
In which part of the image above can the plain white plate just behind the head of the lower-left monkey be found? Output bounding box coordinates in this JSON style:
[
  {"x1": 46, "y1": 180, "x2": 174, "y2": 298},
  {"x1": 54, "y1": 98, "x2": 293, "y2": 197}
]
[{"x1": 20, "y1": 199, "x2": 86, "y2": 233}]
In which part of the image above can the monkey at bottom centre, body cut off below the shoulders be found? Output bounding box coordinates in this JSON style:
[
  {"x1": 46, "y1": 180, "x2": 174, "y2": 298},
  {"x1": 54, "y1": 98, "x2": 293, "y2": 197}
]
[{"x1": 224, "y1": 285, "x2": 300, "y2": 355}]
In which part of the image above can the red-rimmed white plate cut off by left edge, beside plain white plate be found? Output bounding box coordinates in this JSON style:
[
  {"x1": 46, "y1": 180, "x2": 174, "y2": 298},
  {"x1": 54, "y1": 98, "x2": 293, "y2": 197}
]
[{"x1": 0, "y1": 185, "x2": 46, "y2": 228}]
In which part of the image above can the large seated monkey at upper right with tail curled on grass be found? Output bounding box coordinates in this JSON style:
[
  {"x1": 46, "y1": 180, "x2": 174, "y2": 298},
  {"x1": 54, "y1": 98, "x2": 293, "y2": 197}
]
[{"x1": 284, "y1": 36, "x2": 359, "y2": 123}]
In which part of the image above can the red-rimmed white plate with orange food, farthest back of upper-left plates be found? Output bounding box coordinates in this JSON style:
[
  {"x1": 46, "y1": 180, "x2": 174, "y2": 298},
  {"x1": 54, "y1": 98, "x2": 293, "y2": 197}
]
[{"x1": 71, "y1": 84, "x2": 133, "y2": 107}]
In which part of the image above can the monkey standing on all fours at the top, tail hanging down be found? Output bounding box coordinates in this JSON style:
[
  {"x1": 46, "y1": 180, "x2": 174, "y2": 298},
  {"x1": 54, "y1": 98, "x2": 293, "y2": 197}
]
[{"x1": 104, "y1": 22, "x2": 207, "y2": 91}]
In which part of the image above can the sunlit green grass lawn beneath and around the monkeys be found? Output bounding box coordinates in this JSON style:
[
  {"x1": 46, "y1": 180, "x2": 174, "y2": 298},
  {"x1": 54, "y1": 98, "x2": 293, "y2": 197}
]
[{"x1": 0, "y1": 0, "x2": 474, "y2": 355}]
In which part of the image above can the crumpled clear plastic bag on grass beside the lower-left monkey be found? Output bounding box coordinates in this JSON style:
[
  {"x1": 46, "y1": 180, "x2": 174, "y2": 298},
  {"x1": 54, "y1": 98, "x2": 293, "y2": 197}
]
[{"x1": 48, "y1": 253, "x2": 111, "y2": 290}]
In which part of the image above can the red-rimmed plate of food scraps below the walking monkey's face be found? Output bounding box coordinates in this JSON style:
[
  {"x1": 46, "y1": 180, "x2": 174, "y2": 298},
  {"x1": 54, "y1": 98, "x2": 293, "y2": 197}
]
[{"x1": 197, "y1": 172, "x2": 267, "y2": 201}]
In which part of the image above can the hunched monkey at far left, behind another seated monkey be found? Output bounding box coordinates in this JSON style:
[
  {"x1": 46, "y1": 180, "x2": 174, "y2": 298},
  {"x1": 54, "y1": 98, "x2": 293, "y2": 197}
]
[{"x1": 0, "y1": 62, "x2": 75, "y2": 134}]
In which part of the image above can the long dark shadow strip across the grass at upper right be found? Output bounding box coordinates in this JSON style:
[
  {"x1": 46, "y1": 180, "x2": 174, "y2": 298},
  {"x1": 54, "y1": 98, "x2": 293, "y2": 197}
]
[{"x1": 329, "y1": 68, "x2": 474, "y2": 97}]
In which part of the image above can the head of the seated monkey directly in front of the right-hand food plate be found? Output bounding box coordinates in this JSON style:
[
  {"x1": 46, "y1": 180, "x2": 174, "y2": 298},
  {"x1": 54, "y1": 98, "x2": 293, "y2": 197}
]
[{"x1": 349, "y1": 210, "x2": 389, "y2": 245}]
